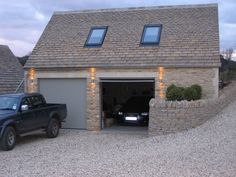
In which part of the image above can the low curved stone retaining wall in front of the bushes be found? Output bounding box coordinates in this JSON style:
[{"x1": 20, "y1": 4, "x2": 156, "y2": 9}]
[{"x1": 149, "y1": 83, "x2": 236, "y2": 135}]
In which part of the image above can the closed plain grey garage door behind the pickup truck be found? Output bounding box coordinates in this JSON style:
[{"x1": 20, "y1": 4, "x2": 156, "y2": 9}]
[{"x1": 39, "y1": 79, "x2": 87, "y2": 129}]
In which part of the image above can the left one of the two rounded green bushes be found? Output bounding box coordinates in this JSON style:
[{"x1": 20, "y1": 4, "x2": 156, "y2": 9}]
[{"x1": 166, "y1": 85, "x2": 184, "y2": 101}]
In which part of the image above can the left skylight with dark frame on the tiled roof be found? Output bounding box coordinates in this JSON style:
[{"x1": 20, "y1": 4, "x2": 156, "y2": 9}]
[{"x1": 85, "y1": 27, "x2": 107, "y2": 46}]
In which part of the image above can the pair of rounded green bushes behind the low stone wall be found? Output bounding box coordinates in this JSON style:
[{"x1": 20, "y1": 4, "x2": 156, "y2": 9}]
[{"x1": 166, "y1": 84, "x2": 202, "y2": 101}]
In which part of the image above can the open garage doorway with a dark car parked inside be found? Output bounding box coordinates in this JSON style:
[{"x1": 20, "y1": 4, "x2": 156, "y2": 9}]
[{"x1": 101, "y1": 79, "x2": 155, "y2": 130}]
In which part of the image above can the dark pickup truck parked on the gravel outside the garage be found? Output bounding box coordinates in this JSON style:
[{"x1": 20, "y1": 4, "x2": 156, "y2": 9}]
[{"x1": 0, "y1": 93, "x2": 67, "y2": 150}]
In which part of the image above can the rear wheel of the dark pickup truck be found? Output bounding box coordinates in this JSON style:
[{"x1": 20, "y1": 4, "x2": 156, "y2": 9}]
[{"x1": 46, "y1": 119, "x2": 60, "y2": 138}]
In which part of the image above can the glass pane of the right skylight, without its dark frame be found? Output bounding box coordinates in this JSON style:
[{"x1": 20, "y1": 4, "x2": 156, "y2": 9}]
[{"x1": 143, "y1": 27, "x2": 160, "y2": 43}]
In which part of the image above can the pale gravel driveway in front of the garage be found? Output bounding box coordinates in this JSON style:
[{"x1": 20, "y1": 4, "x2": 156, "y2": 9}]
[{"x1": 0, "y1": 102, "x2": 236, "y2": 177}]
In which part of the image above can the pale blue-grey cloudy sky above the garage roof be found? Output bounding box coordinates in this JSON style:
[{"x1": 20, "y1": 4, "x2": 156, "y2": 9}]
[{"x1": 0, "y1": 0, "x2": 236, "y2": 56}]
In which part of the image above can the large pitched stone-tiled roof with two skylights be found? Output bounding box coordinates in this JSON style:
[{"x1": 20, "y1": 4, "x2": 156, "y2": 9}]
[{"x1": 26, "y1": 4, "x2": 220, "y2": 68}]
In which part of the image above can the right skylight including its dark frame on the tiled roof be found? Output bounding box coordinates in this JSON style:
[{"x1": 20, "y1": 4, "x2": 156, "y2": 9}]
[{"x1": 141, "y1": 25, "x2": 162, "y2": 45}]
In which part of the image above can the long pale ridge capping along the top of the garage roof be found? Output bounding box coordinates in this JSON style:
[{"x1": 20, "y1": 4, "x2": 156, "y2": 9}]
[{"x1": 54, "y1": 3, "x2": 218, "y2": 15}]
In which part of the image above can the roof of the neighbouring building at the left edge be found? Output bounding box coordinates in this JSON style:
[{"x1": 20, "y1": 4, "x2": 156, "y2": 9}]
[{"x1": 0, "y1": 45, "x2": 24, "y2": 94}]
